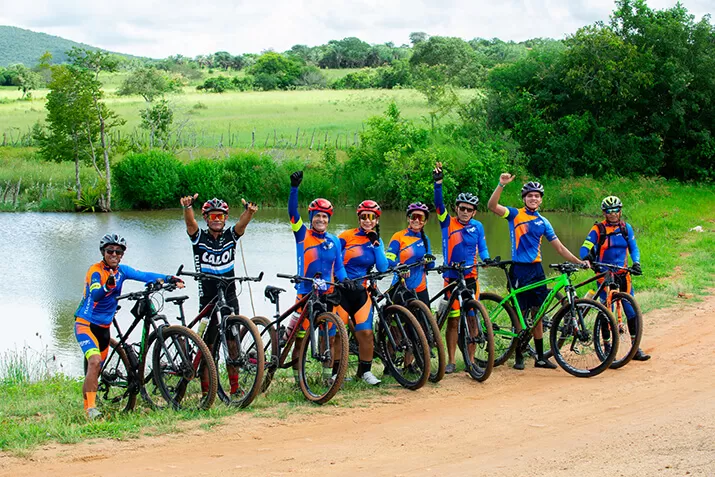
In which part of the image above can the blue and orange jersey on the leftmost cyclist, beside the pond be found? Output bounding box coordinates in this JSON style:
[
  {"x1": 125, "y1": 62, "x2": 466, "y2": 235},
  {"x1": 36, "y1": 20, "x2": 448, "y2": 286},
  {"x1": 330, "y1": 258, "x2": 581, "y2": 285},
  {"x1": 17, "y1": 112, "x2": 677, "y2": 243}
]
[{"x1": 75, "y1": 261, "x2": 171, "y2": 325}]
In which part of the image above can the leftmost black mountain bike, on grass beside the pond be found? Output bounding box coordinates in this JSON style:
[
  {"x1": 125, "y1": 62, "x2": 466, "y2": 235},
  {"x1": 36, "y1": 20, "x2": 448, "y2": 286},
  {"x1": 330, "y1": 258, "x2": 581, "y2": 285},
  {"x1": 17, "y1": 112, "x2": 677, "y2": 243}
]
[{"x1": 97, "y1": 282, "x2": 218, "y2": 411}]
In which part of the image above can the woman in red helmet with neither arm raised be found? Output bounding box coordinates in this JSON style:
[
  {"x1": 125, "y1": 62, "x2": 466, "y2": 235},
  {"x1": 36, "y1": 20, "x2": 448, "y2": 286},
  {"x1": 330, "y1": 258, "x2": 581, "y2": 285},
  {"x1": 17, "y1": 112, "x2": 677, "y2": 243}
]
[{"x1": 338, "y1": 200, "x2": 388, "y2": 385}]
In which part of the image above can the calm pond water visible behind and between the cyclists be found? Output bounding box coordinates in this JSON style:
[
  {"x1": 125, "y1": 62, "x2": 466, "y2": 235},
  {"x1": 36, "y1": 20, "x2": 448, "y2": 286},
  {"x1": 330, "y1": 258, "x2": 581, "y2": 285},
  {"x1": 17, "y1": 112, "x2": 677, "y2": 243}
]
[{"x1": 0, "y1": 209, "x2": 593, "y2": 374}]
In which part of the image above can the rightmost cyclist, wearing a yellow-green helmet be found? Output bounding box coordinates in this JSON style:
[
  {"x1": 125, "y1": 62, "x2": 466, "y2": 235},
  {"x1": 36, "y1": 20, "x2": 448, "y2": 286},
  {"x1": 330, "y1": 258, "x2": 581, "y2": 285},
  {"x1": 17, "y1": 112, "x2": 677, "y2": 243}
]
[{"x1": 579, "y1": 195, "x2": 650, "y2": 361}]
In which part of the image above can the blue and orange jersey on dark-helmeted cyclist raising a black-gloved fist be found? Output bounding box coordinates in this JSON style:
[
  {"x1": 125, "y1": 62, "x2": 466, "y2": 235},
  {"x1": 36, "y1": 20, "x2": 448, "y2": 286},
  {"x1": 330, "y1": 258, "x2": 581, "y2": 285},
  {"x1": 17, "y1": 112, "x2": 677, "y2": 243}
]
[{"x1": 434, "y1": 182, "x2": 489, "y2": 278}]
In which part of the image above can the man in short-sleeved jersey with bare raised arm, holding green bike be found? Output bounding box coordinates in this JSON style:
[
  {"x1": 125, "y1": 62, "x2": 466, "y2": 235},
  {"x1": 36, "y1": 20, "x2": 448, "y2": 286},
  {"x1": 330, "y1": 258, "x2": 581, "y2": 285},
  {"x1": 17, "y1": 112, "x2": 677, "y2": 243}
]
[{"x1": 487, "y1": 173, "x2": 588, "y2": 370}]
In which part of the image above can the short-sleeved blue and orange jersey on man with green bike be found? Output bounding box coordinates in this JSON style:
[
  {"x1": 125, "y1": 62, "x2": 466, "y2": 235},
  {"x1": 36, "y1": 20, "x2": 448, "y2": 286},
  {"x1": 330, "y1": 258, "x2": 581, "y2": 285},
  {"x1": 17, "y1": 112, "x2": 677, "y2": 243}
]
[{"x1": 502, "y1": 207, "x2": 558, "y2": 263}]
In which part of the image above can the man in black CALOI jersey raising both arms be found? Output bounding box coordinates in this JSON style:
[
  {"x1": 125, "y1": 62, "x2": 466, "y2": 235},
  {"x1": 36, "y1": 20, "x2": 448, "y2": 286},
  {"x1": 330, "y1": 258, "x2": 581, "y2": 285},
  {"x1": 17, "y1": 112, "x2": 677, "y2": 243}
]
[{"x1": 180, "y1": 194, "x2": 258, "y2": 394}]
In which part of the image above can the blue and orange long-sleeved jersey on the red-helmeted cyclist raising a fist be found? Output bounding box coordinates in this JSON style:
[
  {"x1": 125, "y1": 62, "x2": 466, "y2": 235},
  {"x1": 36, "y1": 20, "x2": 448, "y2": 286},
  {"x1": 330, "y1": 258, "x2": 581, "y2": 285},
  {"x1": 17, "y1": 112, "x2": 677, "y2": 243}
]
[{"x1": 288, "y1": 187, "x2": 347, "y2": 294}]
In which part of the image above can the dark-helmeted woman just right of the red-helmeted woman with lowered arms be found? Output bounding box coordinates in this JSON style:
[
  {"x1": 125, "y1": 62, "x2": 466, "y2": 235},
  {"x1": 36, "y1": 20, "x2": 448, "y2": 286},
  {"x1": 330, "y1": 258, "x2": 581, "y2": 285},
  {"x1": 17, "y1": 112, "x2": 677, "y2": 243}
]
[{"x1": 386, "y1": 202, "x2": 434, "y2": 306}]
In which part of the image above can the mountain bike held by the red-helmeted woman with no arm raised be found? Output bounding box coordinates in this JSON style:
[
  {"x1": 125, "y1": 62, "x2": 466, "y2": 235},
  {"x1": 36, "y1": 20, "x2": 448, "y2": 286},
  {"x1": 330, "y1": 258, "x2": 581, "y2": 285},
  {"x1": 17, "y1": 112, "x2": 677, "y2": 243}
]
[{"x1": 342, "y1": 265, "x2": 431, "y2": 391}]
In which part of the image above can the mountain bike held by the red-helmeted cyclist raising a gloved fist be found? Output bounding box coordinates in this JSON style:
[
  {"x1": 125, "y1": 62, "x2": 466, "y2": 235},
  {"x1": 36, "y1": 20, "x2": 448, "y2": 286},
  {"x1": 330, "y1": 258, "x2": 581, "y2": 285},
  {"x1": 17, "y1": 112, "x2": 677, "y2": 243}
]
[{"x1": 252, "y1": 273, "x2": 348, "y2": 404}]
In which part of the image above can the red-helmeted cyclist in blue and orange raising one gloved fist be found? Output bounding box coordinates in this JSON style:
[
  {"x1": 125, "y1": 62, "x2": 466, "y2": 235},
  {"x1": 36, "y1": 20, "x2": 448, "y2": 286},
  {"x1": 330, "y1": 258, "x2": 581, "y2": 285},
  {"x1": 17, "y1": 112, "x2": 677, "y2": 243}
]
[{"x1": 288, "y1": 171, "x2": 347, "y2": 383}]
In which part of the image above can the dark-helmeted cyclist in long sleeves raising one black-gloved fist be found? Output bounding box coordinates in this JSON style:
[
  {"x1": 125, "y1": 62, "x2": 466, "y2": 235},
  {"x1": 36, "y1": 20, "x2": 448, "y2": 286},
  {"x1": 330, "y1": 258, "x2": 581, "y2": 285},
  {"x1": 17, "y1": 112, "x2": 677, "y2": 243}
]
[{"x1": 432, "y1": 162, "x2": 489, "y2": 373}]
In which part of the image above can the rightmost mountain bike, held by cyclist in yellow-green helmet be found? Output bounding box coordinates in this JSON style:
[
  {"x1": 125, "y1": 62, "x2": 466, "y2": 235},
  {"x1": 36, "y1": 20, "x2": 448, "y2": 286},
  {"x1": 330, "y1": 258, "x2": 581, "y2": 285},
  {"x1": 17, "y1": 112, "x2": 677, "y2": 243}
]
[{"x1": 574, "y1": 262, "x2": 643, "y2": 369}]
